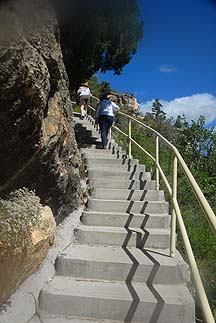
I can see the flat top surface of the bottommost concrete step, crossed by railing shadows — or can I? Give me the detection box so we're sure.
[42,276,192,304]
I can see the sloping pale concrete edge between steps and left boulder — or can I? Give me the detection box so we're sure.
[0,207,83,323]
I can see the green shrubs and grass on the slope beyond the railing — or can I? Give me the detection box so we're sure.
[115,100,216,322]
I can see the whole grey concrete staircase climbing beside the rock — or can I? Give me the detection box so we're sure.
[36,118,195,323]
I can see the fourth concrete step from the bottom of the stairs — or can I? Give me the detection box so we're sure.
[82,211,170,229]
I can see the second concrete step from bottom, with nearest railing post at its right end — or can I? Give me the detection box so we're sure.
[56,244,187,284]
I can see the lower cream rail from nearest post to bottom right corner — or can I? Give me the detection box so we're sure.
[173,199,215,323]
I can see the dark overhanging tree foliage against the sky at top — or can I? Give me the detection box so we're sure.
[53,0,143,88]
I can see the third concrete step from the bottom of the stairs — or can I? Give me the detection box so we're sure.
[75,225,170,249]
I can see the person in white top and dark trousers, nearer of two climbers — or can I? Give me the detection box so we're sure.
[95,93,119,149]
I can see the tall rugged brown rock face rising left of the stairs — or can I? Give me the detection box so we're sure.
[0,0,80,222]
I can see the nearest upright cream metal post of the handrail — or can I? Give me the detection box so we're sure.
[170,155,178,258]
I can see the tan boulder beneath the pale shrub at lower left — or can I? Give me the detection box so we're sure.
[0,206,56,304]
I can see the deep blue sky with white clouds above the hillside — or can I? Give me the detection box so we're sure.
[99,0,216,124]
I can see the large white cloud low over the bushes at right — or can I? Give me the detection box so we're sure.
[140,93,216,124]
